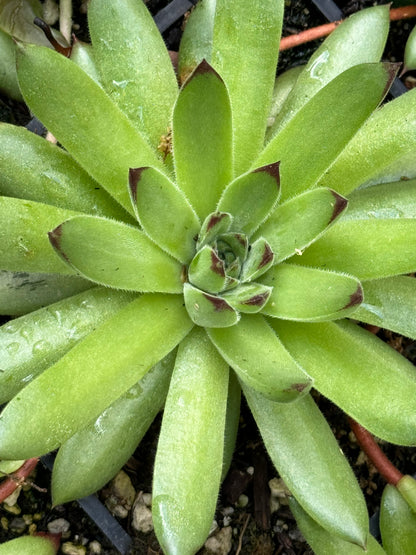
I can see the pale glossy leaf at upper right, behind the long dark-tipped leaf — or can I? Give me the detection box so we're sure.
[272,6,389,133]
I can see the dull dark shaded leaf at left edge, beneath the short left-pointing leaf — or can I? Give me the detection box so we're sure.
[0,270,93,316]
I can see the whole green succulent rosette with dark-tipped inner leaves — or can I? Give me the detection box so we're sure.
[0,0,416,555]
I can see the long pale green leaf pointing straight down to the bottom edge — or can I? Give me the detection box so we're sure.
[152,329,228,555]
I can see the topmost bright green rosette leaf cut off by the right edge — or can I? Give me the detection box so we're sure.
[320,86,416,194]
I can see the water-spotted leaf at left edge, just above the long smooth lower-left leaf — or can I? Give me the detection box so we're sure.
[0,288,134,403]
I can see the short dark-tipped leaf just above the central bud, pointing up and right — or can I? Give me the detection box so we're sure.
[217,162,280,236]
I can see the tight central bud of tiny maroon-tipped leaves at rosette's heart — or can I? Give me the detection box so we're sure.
[184,212,274,328]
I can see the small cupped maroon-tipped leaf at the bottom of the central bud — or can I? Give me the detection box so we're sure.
[183,283,240,328]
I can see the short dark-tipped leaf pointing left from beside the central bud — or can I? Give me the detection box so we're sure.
[49,216,182,293]
